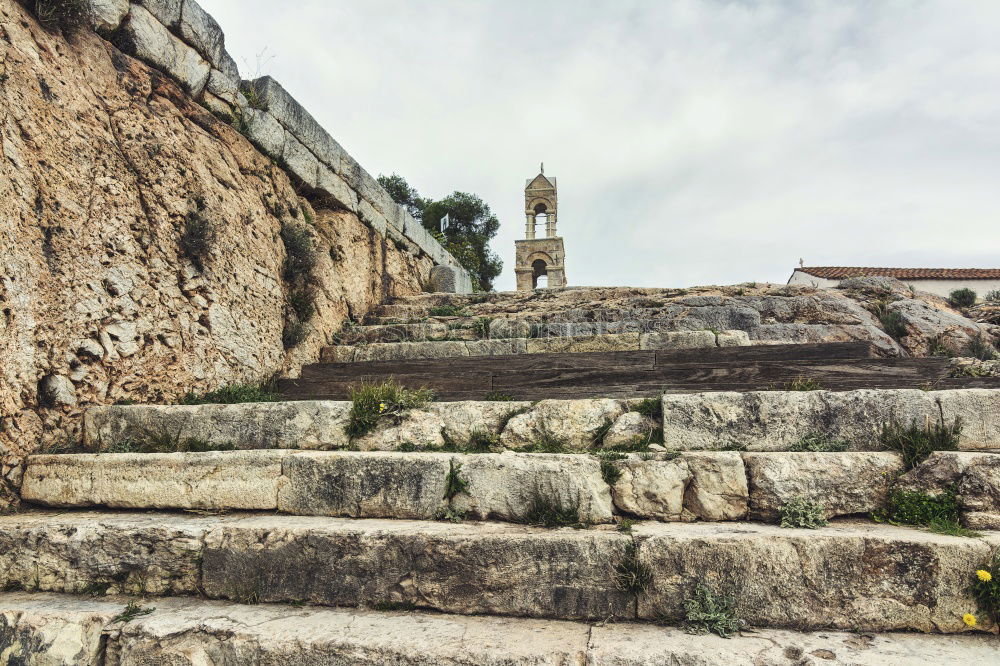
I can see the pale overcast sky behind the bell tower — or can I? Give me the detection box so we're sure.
[200,0,1000,289]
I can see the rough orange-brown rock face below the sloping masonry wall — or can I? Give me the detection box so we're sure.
[0,0,432,498]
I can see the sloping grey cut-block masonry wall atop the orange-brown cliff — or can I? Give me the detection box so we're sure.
[90,0,472,293]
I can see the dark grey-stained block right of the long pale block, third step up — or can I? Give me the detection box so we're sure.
[278,452,452,520]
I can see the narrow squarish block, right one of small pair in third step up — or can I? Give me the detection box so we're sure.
[682,451,750,520]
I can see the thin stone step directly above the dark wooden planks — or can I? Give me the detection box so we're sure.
[320,324,750,363]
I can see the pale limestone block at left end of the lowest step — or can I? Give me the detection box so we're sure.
[0,592,114,666]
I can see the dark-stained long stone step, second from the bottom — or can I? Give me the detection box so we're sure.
[0,511,1000,633]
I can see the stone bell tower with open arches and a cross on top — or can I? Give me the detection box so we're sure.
[514,164,566,291]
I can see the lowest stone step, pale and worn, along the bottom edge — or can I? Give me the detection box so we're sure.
[0,593,997,666]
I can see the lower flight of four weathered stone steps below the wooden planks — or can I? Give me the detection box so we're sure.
[0,382,1000,665]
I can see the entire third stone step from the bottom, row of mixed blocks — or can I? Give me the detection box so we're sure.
[21,450,1000,529]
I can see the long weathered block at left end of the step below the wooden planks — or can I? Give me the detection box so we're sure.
[83,400,351,450]
